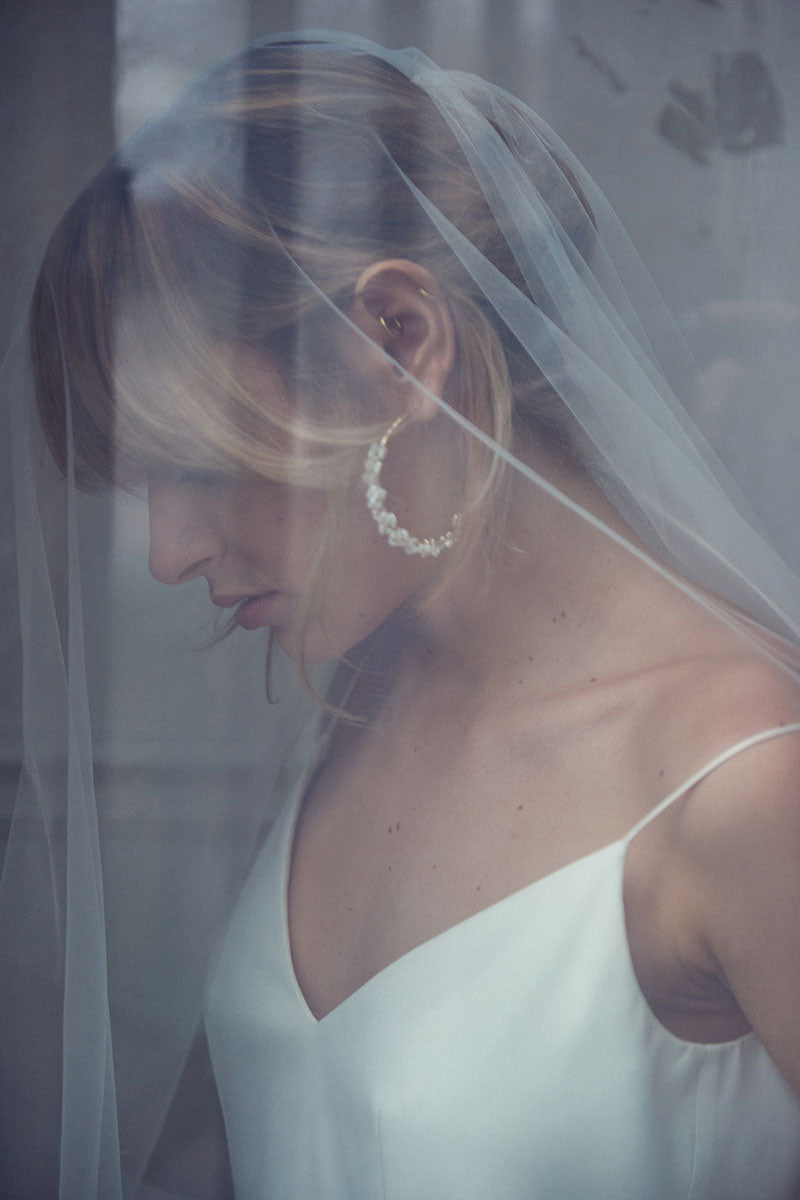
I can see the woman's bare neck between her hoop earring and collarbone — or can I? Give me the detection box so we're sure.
[414,455,666,691]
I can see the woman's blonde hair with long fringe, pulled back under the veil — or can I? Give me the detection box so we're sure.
[30,43,587,696]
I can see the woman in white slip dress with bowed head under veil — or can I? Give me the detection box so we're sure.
[4,35,800,1200]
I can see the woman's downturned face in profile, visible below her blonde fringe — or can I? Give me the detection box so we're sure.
[148,350,453,662]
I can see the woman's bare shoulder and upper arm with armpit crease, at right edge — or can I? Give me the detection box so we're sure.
[627,649,800,1070]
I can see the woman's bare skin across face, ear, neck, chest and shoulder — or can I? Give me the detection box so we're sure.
[150,260,800,1094]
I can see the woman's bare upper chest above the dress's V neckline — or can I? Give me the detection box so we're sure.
[288,715,655,1014]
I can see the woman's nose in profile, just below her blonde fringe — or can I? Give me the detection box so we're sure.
[148,481,224,583]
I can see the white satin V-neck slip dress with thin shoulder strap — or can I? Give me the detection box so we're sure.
[206,726,800,1200]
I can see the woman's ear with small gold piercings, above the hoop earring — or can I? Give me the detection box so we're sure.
[349,258,456,420]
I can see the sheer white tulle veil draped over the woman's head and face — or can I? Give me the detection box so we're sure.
[0,34,800,1200]
